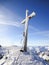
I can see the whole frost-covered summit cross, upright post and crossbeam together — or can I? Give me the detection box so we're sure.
[21,10,36,52]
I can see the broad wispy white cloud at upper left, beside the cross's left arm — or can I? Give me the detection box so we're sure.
[0,5,22,27]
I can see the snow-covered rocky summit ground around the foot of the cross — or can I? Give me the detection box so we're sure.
[0,46,49,65]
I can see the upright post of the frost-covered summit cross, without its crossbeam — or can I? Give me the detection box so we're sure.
[24,10,29,52]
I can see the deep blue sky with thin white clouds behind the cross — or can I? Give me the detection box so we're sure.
[0,0,49,46]
